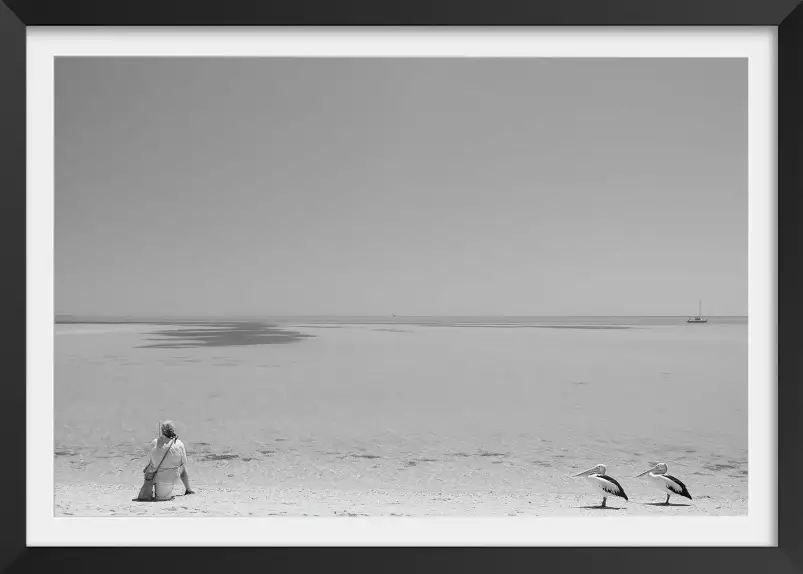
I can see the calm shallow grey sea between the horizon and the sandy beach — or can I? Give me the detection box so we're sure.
[54,317,748,504]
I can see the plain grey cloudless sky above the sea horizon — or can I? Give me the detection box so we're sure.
[55,58,748,317]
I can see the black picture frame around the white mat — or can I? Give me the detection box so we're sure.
[0,0,803,574]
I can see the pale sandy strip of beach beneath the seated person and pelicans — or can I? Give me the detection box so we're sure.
[54,482,747,518]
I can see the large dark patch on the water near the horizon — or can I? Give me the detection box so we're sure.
[140,323,315,352]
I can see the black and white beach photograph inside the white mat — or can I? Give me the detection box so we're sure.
[52,57,752,518]
